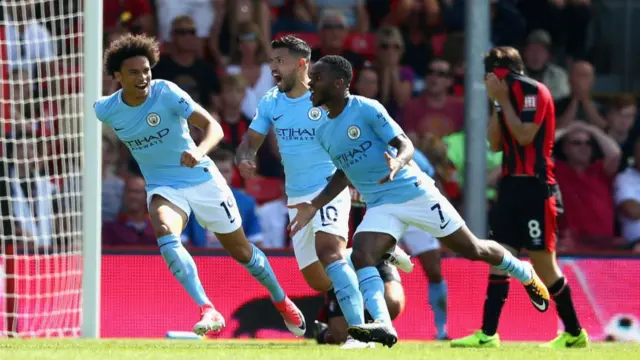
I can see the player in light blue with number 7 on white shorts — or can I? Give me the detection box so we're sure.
[289,56,549,347]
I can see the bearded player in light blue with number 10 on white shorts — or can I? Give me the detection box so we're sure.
[236,36,413,348]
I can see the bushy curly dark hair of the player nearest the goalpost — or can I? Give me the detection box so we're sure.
[104,35,160,76]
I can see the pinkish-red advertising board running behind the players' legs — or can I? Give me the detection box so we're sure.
[0,255,640,341]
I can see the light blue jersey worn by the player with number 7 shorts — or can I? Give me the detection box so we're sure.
[316,95,433,207]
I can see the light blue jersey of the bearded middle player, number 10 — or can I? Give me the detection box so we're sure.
[249,87,336,197]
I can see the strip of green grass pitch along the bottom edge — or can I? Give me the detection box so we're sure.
[0,339,640,360]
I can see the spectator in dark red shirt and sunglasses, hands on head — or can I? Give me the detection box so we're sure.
[556,121,621,250]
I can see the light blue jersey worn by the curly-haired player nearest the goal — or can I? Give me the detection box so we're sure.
[94,80,214,191]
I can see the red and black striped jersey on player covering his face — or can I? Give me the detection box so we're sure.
[498,73,556,184]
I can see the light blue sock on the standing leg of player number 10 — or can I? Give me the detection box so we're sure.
[325,259,364,326]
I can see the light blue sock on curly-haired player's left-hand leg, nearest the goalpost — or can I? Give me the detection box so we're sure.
[158,235,211,306]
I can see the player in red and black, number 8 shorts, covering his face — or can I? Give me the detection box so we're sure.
[451,47,589,348]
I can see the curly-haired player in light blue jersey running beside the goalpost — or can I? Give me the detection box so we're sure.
[94,35,306,336]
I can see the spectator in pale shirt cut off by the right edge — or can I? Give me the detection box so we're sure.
[615,139,640,252]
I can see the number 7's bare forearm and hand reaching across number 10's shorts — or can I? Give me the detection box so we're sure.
[287,170,349,236]
